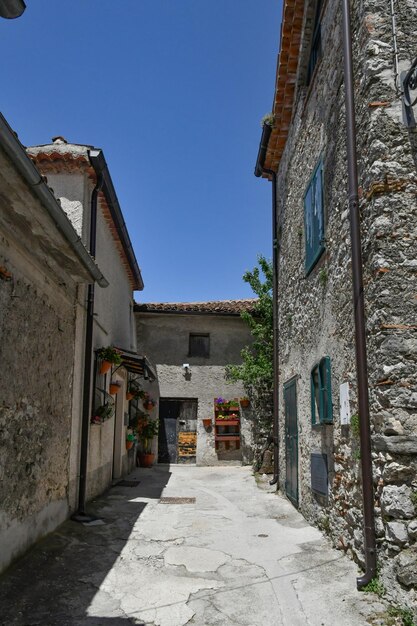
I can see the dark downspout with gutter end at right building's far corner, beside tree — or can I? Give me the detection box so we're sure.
[255,124,279,485]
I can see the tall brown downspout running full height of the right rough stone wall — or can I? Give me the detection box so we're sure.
[342,0,376,589]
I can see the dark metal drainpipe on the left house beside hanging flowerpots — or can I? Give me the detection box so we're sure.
[71,174,103,522]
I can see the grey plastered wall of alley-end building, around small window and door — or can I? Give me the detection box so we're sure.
[136,312,253,465]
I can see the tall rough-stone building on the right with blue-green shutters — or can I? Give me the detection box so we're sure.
[258,0,417,608]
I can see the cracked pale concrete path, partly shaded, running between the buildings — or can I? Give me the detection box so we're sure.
[0,466,381,626]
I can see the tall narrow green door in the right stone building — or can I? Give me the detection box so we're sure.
[284,378,298,506]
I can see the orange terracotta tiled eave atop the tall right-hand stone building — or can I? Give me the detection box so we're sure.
[263,0,305,178]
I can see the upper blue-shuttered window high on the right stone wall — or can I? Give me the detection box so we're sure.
[304,161,324,274]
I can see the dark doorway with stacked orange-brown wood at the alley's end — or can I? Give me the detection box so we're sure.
[158,398,198,463]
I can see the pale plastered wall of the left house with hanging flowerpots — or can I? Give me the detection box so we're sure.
[31,157,136,507]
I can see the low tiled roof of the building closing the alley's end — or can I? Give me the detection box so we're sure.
[135,298,258,315]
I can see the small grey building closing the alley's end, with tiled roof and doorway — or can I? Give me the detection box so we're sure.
[135,300,254,465]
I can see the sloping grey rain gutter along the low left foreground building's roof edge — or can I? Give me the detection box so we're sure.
[0,113,109,287]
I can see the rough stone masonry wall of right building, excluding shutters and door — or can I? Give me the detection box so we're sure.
[277,0,417,604]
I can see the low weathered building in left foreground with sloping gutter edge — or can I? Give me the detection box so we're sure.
[0,115,107,571]
